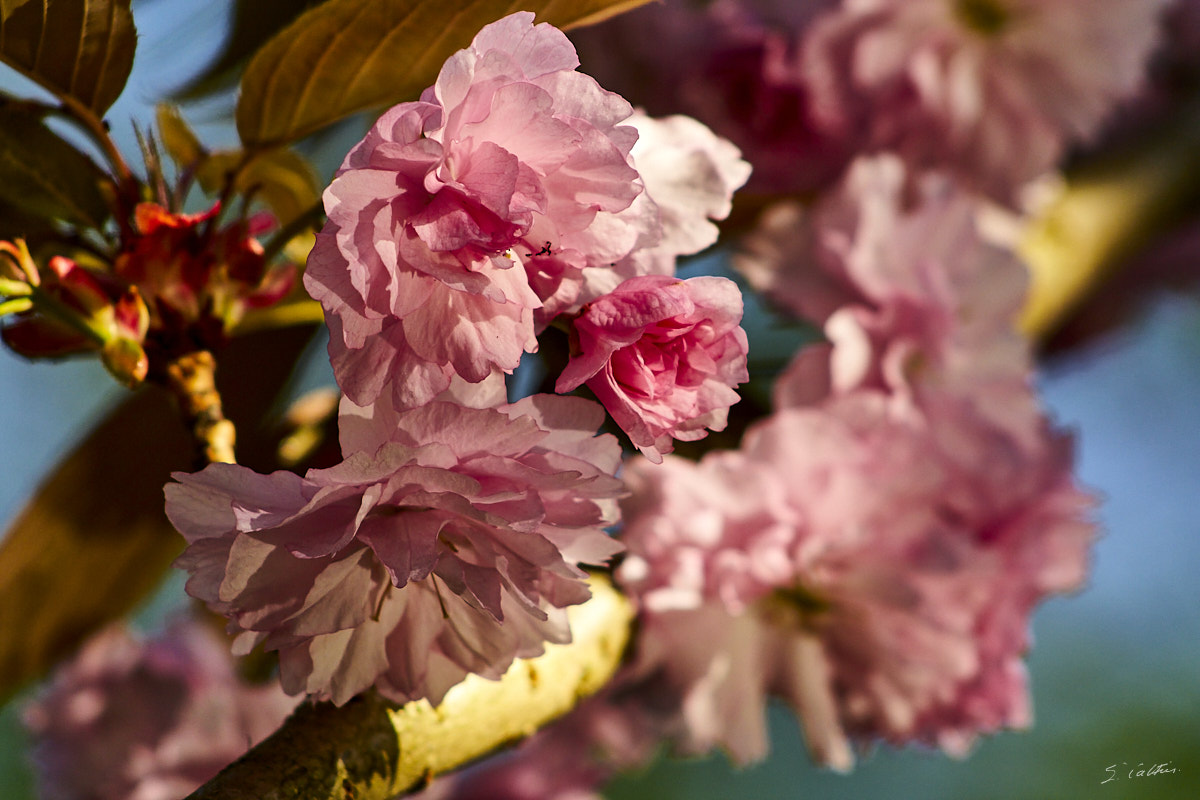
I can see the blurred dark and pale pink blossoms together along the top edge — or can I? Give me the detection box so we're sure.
[577,0,1170,204]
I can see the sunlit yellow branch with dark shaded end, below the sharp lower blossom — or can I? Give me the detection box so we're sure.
[188,577,632,800]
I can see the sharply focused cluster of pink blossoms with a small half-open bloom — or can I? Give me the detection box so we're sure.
[167,13,749,704]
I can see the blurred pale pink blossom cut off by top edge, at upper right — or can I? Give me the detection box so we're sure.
[803,0,1165,204]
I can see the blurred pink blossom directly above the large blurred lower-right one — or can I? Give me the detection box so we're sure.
[736,156,1039,439]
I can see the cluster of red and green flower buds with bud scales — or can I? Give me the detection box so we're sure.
[0,203,294,386]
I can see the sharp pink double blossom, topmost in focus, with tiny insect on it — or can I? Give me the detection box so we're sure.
[305,12,654,407]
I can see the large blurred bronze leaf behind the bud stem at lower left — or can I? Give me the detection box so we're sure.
[0,326,312,703]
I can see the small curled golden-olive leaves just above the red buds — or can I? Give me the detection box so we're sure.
[196,150,320,227]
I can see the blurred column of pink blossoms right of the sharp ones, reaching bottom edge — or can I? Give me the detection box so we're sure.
[422,157,1094,800]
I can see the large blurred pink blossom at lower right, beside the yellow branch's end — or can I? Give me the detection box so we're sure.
[618,391,1094,769]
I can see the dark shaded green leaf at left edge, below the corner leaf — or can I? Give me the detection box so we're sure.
[0,109,109,228]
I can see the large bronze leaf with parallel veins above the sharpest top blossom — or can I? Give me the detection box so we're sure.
[238,0,648,148]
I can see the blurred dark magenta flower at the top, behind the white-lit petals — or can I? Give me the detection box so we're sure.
[571,0,853,193]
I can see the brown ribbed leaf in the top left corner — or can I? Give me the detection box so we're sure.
[0,0,137,115]
